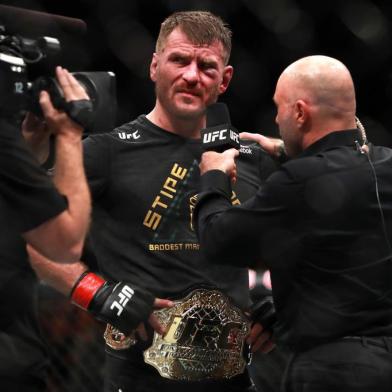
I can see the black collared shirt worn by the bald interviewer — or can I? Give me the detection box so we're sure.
[194,130,392,350]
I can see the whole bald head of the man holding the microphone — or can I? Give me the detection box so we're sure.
[274,56,356,156]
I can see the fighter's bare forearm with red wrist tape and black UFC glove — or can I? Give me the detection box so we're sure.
[27,245,162,334]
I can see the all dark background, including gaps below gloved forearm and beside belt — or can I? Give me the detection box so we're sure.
[0,0,392,392]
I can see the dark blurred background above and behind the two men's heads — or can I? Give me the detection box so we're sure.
[0,0,392,145]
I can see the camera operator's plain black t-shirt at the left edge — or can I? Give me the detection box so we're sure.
[0,120,67,379]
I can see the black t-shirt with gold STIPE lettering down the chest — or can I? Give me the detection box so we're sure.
[84,116,275,308]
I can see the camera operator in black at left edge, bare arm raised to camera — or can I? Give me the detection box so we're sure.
[0,67,90,391]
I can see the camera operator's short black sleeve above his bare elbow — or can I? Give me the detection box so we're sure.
[0,120,67,232]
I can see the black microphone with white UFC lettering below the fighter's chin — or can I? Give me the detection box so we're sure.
[200,102,240,152]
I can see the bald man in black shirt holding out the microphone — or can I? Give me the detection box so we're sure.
[195,56,392,392]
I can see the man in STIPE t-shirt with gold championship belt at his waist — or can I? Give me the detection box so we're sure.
[29,11,274,392]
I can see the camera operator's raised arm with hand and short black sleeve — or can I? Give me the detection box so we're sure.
[0,67,90,262]
